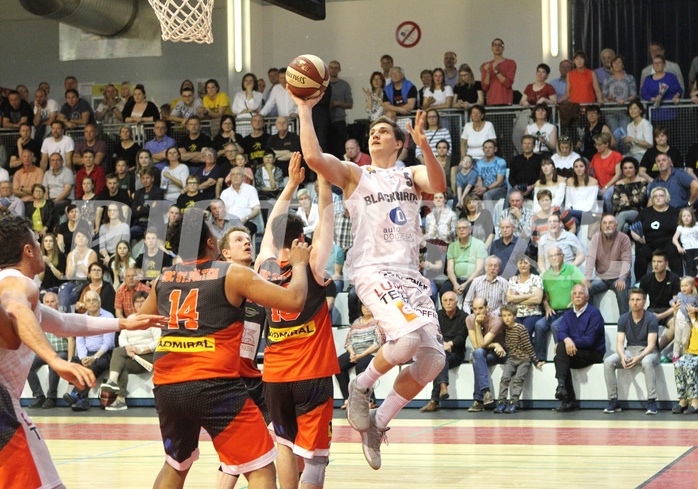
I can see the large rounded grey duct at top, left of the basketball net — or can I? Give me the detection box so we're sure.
[19,0,138,37]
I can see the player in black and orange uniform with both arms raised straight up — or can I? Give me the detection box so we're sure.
[255,153,339,489]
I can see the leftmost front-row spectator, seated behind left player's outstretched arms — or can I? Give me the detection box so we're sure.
[27,292,75,409]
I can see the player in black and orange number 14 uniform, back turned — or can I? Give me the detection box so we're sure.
[141,209,312,489]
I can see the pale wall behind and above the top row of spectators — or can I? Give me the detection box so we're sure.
[0,0,566,119]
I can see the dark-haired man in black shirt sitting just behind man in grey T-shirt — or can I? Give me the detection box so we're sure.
[640,249,680,356]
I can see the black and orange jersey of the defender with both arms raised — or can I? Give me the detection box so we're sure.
[259,258,339,382]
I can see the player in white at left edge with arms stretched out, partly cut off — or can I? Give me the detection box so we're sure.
[0,217,167,489]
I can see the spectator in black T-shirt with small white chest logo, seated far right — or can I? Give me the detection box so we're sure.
[630,187,683,278]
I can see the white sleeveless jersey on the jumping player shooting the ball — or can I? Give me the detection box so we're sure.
[345,166,422,270]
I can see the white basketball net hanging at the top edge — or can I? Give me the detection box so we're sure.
[148,0,214,44]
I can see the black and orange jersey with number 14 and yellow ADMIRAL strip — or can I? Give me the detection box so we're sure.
[153,260,245,385]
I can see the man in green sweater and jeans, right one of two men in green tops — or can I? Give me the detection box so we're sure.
[533,246,584,361]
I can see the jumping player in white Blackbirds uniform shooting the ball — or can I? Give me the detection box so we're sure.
[293,91,446,469]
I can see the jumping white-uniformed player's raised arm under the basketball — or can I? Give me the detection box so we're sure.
[287,89,360,189]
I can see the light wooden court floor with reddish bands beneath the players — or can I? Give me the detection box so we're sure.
[28,408,698,489]
